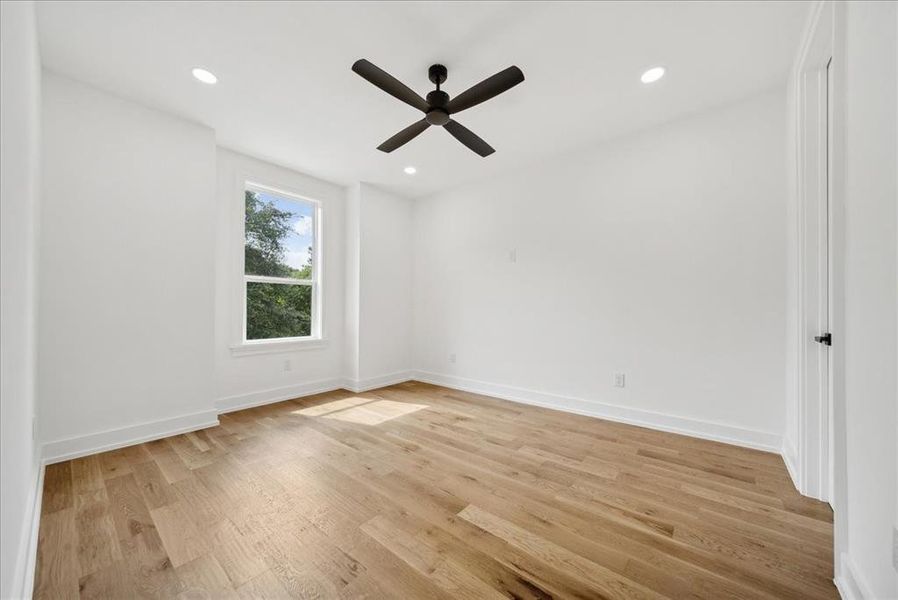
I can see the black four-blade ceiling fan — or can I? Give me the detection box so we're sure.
[352,58,524,156]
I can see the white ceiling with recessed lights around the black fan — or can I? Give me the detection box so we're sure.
[38,1,808,197]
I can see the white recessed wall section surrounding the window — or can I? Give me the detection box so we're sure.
[209,150,346,410]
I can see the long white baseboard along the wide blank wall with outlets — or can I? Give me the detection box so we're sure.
[414,371,782,454]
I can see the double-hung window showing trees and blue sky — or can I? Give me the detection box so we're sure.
[243,184,321,342]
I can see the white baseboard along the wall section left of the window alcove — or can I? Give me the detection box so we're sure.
[41,410,218,465]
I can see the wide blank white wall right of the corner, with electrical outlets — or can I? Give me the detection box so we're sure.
[413,90,787,451]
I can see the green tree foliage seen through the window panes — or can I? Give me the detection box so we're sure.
[244,191,312,340]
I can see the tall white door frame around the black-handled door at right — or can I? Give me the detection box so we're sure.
[787,2,845,505]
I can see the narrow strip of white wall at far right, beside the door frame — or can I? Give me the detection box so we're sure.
[836,2,898,599]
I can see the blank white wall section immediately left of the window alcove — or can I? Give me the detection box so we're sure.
[38,73,216,457]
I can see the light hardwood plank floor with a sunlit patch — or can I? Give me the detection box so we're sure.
[35,383,838,600]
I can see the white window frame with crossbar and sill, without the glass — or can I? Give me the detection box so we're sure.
[231,177,327,356]
